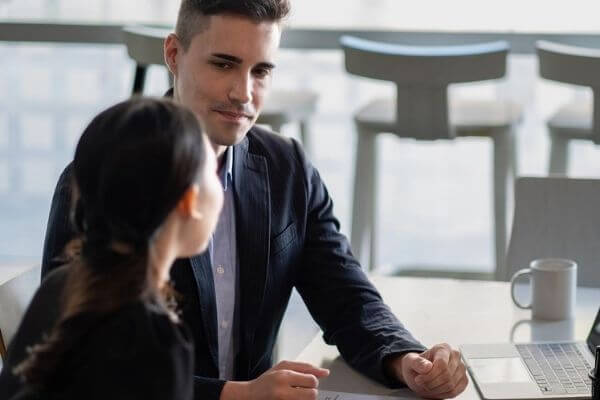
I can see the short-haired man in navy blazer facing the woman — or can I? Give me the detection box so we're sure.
[8,0,468,400]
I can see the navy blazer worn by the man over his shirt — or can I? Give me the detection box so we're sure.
[34,126,425,399]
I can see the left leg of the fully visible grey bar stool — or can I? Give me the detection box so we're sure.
[350,130,377,270]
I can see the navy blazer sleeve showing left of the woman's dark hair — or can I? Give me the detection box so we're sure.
[42,164,75,279]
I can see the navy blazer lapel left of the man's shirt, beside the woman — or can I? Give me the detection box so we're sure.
[190,250,219,371]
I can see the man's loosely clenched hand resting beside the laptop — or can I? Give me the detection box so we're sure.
[387,343,469,399]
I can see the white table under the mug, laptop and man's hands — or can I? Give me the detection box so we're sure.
[298,277,600,399]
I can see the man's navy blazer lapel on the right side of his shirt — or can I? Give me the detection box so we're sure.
[233,137,271,368]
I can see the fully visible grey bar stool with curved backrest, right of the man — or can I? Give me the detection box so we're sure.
[341,36,521,269]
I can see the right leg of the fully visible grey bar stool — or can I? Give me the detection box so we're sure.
[493,129,515,279]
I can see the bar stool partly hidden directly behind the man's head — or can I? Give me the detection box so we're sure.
[123,26,318,154]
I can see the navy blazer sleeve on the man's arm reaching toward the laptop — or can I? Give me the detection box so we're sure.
[294,142,426,386]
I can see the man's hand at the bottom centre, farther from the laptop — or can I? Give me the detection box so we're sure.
[221,361,329,400]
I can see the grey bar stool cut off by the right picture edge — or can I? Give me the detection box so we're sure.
[536,41,600,175]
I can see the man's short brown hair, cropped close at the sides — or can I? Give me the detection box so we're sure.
[175,0,290,50]
